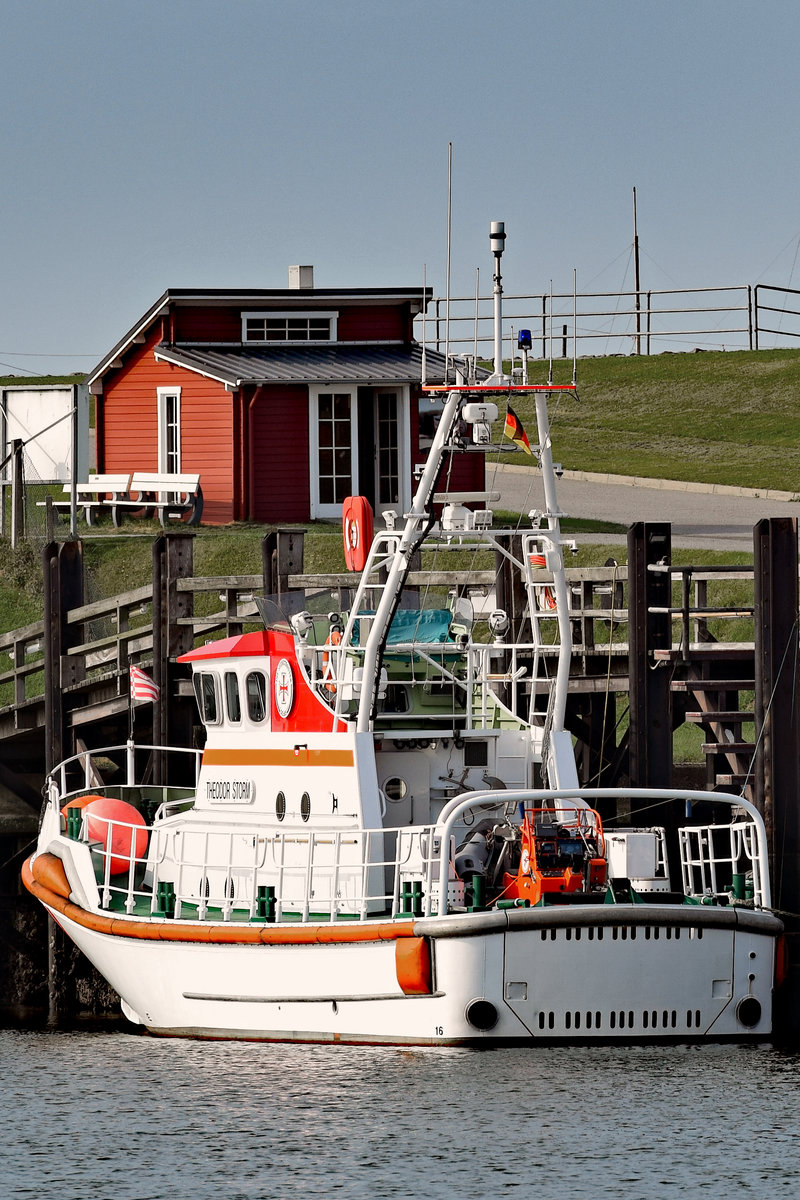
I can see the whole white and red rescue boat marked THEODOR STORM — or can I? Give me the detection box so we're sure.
[23,222,782,1044]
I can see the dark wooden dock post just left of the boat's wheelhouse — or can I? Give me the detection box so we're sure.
[152,533,194,784]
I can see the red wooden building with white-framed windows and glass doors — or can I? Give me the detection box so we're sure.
[89,276,483,524]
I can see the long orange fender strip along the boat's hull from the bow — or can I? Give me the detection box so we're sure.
[22,854,414,946]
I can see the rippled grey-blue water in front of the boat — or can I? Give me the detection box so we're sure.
[0,1031,800,1200]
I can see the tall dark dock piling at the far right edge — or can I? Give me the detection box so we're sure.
[753,517,800,1040]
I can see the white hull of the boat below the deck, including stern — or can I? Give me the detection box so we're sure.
[45,905,780,1044]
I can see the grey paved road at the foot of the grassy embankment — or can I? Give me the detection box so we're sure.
[487,464,800,551]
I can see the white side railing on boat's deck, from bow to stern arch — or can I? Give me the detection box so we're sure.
[62,810,450,922]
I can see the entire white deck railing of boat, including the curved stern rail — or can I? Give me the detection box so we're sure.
[56,788,770,922]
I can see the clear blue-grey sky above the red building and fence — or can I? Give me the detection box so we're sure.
[0,0,800,373]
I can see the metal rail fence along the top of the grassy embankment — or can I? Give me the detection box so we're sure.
[415,283,800,359]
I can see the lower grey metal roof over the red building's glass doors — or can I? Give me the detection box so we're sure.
[149,342,445,388]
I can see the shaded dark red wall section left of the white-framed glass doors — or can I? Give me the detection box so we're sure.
[251,386,311,524]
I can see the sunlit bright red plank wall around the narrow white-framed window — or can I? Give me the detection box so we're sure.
[97,331,237,524]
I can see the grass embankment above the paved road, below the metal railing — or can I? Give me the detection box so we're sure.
[509,350,800,492]
